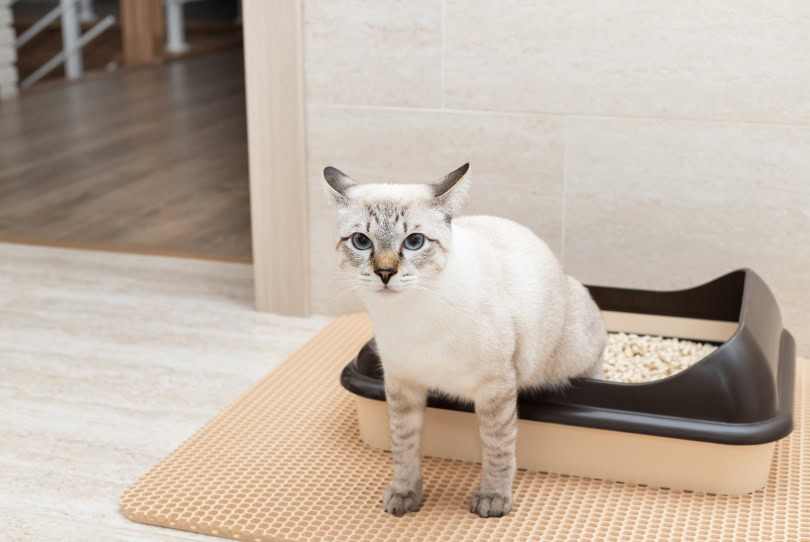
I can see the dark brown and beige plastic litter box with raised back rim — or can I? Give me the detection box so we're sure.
[340,269,796,495]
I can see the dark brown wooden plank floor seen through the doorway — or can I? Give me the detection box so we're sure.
[0,50,250,261]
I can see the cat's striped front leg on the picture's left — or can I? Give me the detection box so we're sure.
[383,376,427,516]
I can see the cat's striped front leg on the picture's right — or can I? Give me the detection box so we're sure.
[470,381,517,518]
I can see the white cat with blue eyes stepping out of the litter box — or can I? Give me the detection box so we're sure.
[324,164,607,517]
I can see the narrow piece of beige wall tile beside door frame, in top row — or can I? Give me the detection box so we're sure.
[304,0,442,107]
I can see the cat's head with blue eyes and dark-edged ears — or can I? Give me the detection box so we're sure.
[323,164,469,297]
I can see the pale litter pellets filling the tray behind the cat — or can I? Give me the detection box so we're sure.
[602,333,717,383]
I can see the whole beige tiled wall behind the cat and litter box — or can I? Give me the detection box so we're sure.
[304,0,810,355]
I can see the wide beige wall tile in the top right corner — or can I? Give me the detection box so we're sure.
[445,0,810,122]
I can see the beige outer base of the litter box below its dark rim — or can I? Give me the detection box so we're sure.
[356,397,776,495]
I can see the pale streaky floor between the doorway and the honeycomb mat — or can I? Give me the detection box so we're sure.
[0,243,329,541]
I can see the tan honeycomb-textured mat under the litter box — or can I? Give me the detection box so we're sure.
[121,315,810,542]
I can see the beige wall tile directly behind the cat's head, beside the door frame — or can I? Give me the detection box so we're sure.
[308,106,563,313]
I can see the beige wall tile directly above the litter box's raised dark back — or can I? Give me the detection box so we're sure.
[564,119,810,354]
